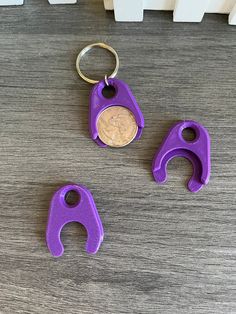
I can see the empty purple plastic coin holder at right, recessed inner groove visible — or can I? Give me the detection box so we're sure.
[152,120,211,192]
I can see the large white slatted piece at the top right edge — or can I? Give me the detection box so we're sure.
[104,0,236,25]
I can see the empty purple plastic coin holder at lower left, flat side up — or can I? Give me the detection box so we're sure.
[46,184,104,257]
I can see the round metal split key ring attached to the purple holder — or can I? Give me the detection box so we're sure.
[76,43,120,84]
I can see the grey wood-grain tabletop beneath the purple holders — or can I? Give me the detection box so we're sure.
[0,0,236,314]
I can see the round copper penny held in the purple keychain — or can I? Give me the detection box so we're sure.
[97,106,138,147]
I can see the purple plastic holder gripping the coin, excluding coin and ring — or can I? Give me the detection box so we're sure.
[89,78,144,147]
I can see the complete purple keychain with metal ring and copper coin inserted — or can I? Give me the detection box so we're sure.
[76,43,144,147]
